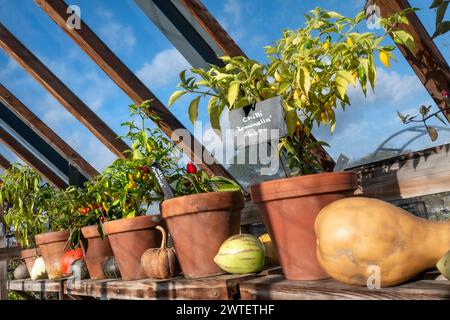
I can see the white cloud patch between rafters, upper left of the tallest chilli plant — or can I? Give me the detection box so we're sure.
[136,48,190,88]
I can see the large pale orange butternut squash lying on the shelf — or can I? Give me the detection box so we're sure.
[315,197,450,287]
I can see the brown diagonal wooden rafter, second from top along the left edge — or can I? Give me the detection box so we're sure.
[0,83,98,177]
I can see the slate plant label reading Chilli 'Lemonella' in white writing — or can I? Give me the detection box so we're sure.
[228,96,287,149]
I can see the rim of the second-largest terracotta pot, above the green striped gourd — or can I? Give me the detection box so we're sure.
[161,191,244,219]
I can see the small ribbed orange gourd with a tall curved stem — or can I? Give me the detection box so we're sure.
[141,226,180,279]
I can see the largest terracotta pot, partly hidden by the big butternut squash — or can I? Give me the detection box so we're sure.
[250,172,356,280]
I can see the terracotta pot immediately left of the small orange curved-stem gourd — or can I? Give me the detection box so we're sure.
[104,215,161,280]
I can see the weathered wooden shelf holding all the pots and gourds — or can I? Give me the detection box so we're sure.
[8,267,450,300]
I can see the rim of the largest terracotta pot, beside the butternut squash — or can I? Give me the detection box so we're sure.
[249,171,357,203]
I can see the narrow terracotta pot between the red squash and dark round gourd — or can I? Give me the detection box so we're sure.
[81,225,114,280]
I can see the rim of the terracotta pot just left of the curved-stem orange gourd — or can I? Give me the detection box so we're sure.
[103,215,159,235]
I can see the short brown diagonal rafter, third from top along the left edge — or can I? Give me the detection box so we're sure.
[0,127,67,188]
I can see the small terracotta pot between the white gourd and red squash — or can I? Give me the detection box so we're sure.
[35,230,70,279]
